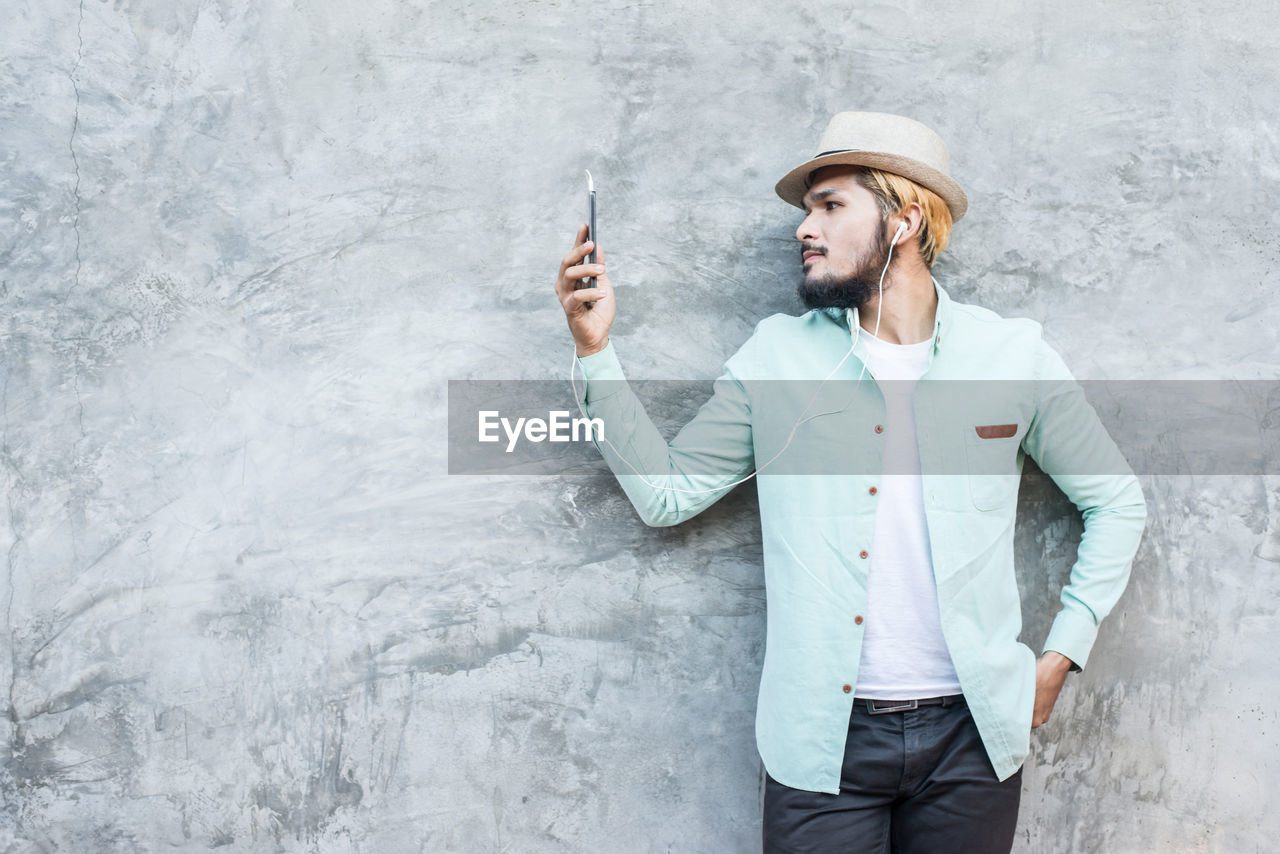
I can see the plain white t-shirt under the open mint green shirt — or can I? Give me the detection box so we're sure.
[854,330,960,700]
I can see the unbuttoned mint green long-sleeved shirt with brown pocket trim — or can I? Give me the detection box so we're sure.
[579,282,1147,794]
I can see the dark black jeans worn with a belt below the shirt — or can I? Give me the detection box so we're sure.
[763,702,1023,854]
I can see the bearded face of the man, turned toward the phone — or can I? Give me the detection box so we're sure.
[796,166,888,309]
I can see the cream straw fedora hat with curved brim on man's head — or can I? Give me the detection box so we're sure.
[774,113,969,222]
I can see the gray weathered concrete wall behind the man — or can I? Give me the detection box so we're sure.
[0,0,1280,853]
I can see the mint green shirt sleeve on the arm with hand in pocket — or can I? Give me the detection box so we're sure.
[1023,341,1147,671]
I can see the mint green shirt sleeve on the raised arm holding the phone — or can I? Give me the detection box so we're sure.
[577,341,755,528]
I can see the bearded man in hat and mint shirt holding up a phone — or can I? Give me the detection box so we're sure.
[556,113,1146,854]
